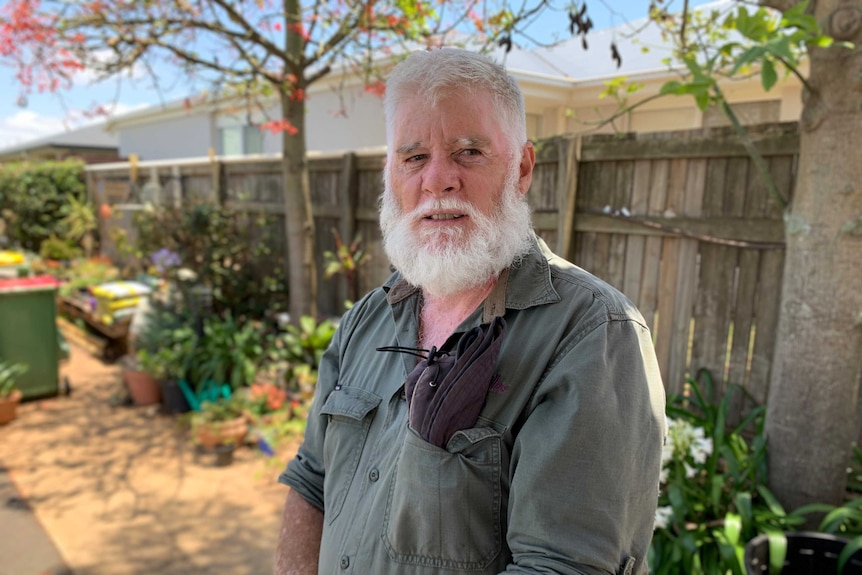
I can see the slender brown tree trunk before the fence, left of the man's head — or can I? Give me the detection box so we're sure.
[281,85,317,324]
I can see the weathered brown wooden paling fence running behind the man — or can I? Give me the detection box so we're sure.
[88,124,799,418]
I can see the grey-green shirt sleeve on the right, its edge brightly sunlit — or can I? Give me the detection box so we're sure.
[505,320,666,575]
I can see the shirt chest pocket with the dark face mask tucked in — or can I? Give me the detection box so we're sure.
[383,428,503,572]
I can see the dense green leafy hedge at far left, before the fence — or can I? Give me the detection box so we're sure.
[0,160,86,252]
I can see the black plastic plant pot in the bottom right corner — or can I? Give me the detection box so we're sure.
[745,531,862,575]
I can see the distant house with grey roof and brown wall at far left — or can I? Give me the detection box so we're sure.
[0,123,121,164]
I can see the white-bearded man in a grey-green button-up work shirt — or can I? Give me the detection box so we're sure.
[275,49,665,575]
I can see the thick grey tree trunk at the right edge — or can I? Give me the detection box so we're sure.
[766,0,862,510]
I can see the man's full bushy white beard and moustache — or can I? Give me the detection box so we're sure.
[380,166,533,297]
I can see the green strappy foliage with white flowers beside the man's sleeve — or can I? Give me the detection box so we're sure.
[649,370,803,575]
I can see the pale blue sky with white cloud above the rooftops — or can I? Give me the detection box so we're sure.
[0,0,706,150]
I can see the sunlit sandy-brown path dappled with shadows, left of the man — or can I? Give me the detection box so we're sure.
[0,341,300,575]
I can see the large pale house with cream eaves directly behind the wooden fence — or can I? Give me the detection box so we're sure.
[71,0,802,161]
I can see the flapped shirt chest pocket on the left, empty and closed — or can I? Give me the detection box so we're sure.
[320,387,381,523]
